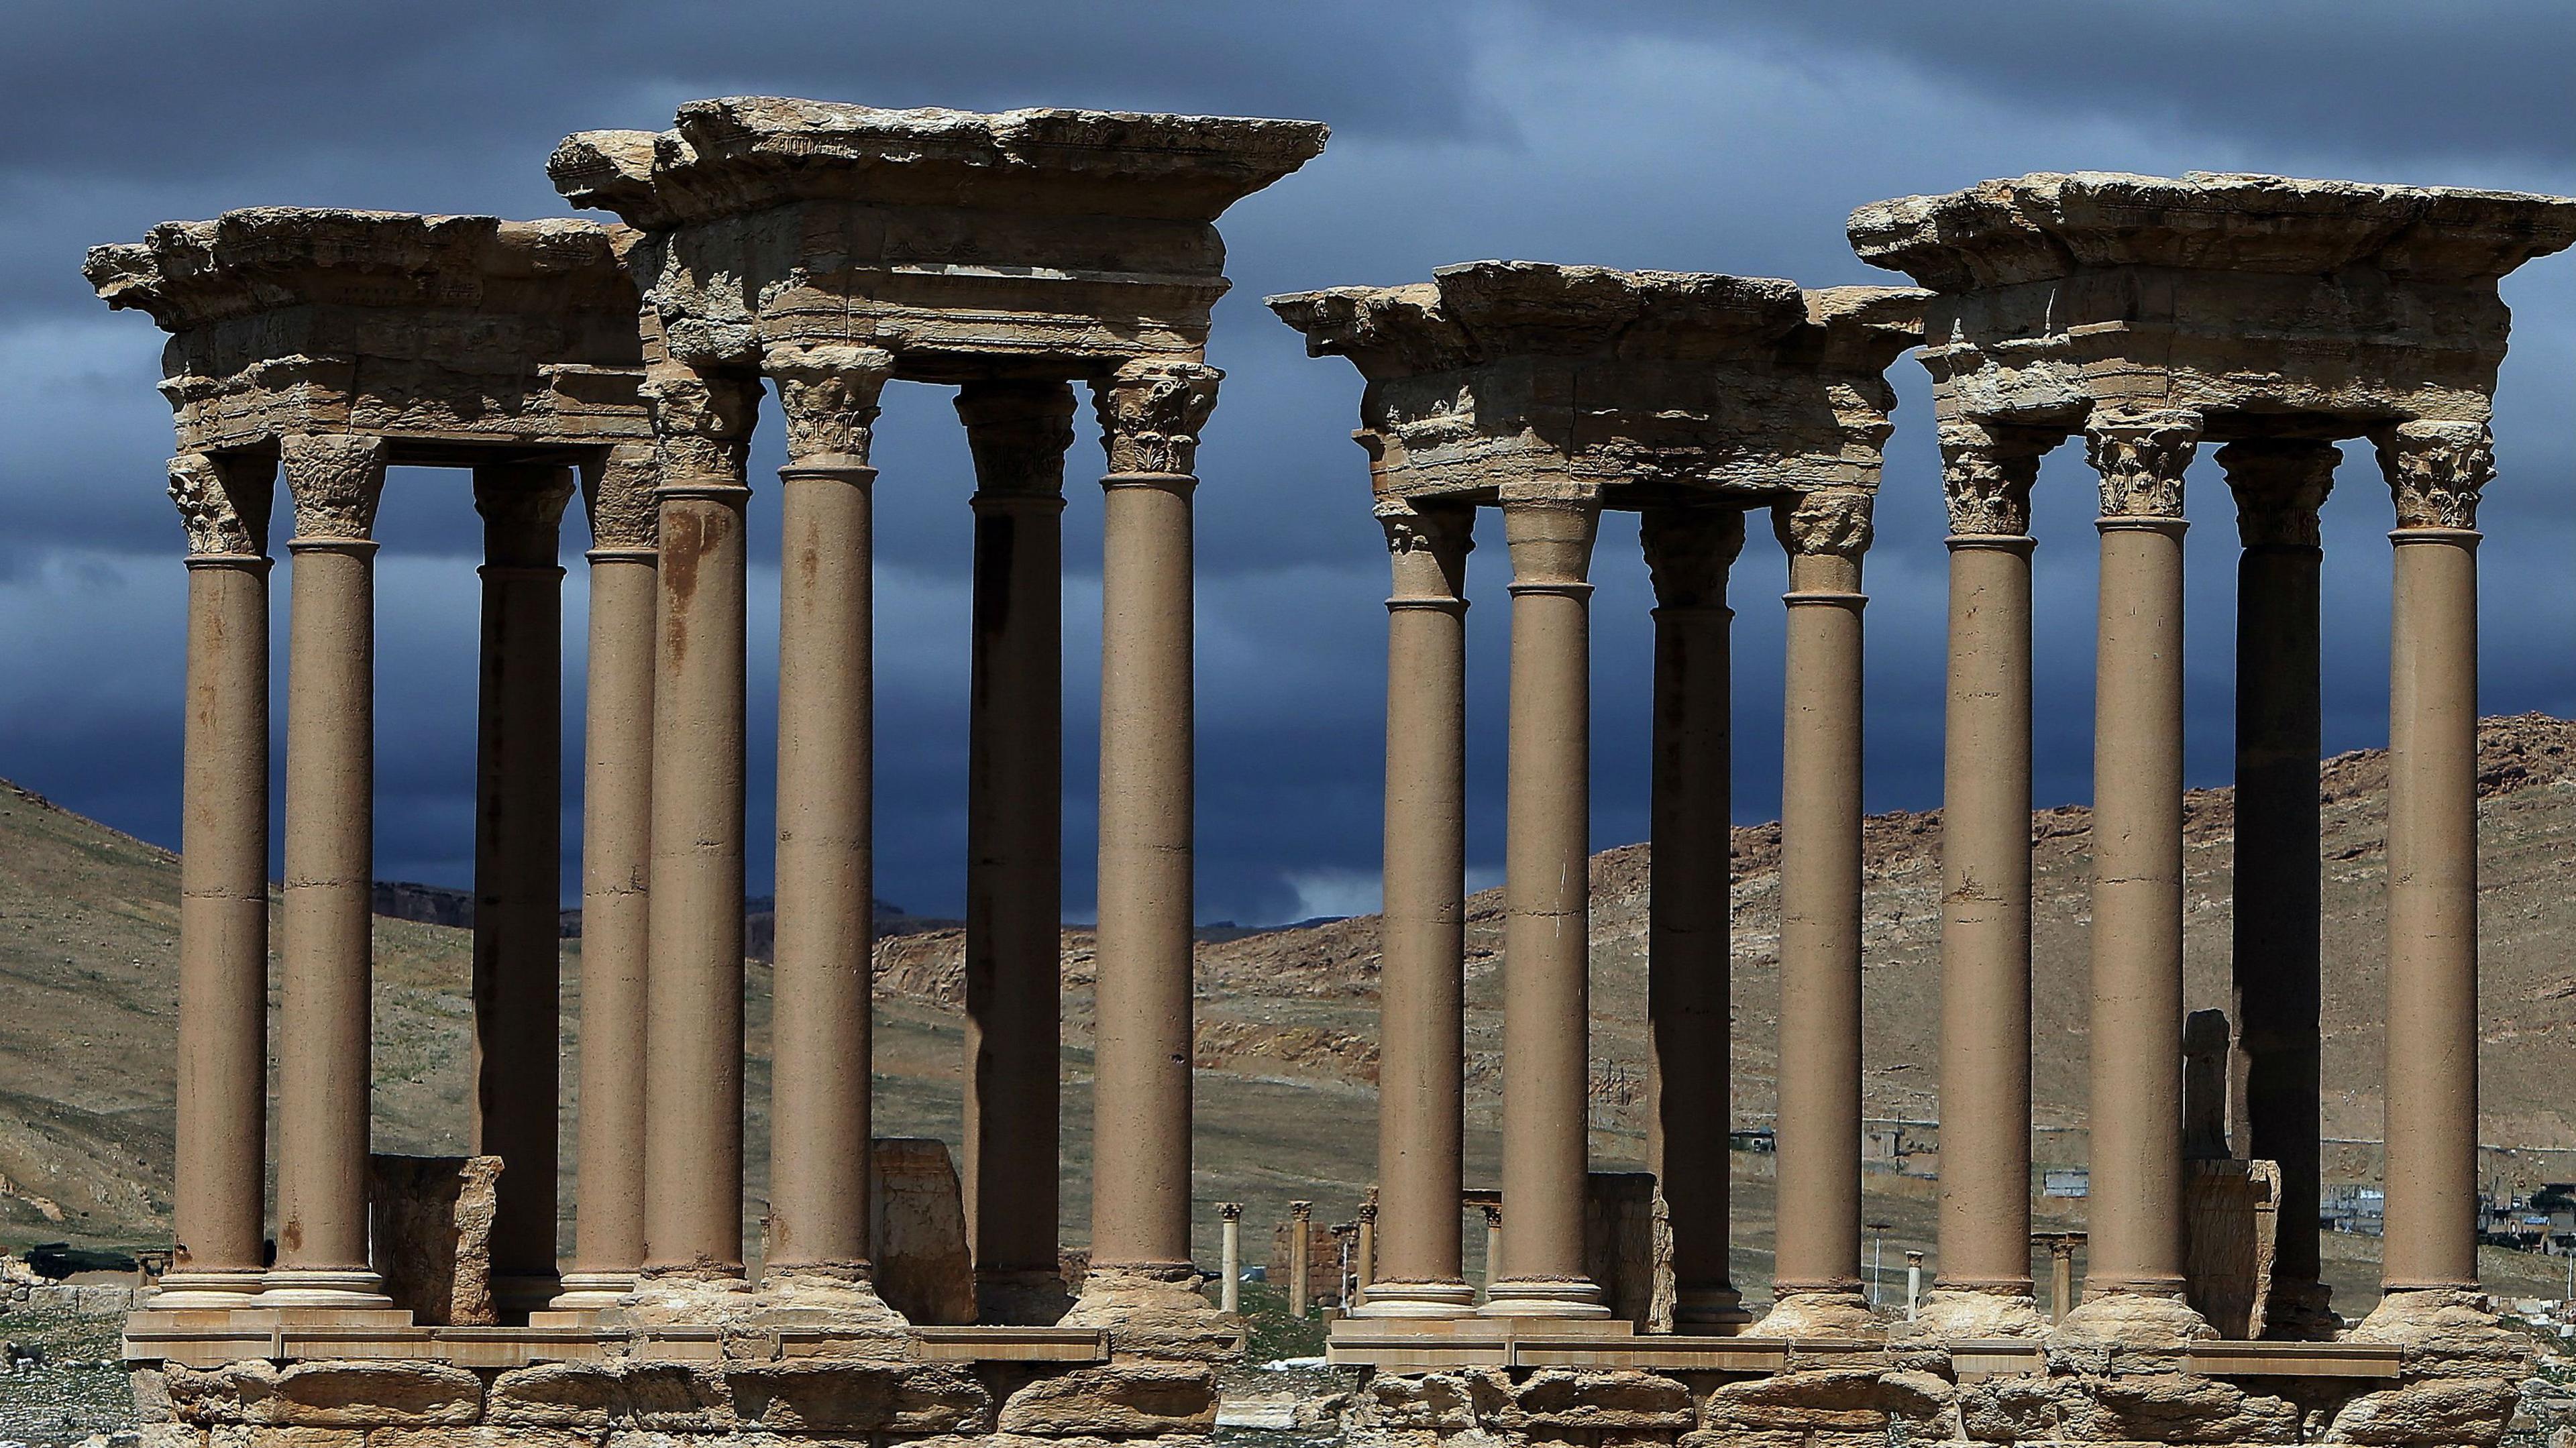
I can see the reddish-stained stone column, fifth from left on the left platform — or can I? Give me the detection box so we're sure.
[639,364,760,1283]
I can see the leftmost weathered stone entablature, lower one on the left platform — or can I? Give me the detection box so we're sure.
[85,206,652,463]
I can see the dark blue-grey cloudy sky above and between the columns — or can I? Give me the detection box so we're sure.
[0,0,2576,922]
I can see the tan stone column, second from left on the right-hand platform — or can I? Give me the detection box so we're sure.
[1479,497,1610,1317]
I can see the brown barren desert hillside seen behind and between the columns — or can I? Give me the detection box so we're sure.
[15,716,2576,1306]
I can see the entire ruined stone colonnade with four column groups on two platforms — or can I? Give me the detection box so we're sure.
[70,98,2576,1448]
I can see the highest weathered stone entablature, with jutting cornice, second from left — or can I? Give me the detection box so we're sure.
[549,95,1327,382]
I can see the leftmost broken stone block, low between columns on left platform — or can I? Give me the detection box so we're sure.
[368,1154,500,1327]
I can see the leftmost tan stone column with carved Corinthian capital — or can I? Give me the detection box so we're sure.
[150,453,276,1311]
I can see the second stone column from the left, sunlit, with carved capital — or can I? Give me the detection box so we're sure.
[263,433,392,1309]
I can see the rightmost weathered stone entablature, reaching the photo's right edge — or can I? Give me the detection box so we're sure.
[1849,170,2576,441]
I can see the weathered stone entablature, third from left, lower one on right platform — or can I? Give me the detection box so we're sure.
[1270,260,1929,508]
